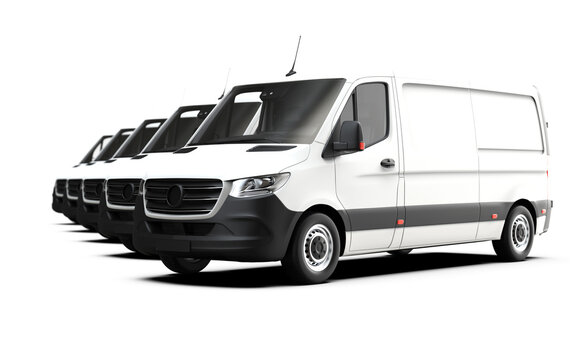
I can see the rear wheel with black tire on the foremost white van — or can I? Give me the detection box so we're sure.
[493,206,534,261]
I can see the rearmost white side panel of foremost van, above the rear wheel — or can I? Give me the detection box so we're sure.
[471,88,548,236]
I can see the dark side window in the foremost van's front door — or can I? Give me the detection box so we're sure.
[334,83,388,147]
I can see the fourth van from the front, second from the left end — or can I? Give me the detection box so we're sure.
[61,128,135,222]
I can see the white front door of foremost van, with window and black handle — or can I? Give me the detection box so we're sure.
[333,78,403,253]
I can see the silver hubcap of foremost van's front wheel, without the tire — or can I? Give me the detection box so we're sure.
[304,224,333,271]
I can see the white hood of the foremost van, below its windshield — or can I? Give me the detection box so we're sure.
[141,143,310,181]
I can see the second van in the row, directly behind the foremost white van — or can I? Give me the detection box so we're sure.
[96,105,214,250]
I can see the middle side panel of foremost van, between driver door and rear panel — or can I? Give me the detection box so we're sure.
[392,82,479,248]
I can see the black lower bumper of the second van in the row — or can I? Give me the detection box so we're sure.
[97,193,133,239]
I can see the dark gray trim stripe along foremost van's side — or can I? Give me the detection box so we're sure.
[346,200,548,231]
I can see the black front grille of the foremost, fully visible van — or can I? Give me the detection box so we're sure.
[144,179,223,215]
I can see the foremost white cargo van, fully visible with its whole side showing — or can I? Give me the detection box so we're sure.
[133,76,552,283]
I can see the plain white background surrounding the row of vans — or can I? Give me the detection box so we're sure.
[0,0,570,359]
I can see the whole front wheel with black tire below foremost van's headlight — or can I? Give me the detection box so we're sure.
[281,213,340,284]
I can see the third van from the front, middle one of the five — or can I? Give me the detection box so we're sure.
[76,119,166,231]
